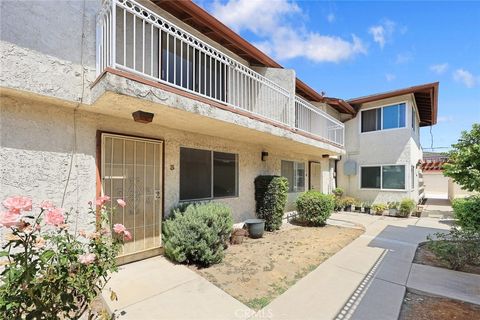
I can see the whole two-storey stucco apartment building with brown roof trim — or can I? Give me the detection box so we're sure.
[0,0,438,259]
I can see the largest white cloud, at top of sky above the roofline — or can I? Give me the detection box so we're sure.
[208,0,367,62]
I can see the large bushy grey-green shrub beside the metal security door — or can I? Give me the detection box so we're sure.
[163,202,233,267]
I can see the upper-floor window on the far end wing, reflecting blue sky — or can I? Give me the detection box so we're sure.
[361,103,406,132]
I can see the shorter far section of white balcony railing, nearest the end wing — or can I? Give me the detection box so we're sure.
[295,96,345,146]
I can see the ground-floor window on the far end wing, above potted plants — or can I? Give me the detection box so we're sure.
[360,165,405,190]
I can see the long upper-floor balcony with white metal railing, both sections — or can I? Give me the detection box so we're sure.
[96,0,344,147]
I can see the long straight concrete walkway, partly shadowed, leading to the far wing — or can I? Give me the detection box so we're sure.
[262,213,449,320]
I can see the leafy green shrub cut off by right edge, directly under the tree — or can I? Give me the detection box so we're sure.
[452,196,480,232]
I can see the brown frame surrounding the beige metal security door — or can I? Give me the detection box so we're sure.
[95,130,166,264]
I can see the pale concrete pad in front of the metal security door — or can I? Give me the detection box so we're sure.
[103,257,254,320]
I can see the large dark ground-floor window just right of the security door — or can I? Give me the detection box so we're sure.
[180,148,238,200]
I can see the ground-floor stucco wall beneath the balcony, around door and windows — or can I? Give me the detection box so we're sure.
[0,98,330,227]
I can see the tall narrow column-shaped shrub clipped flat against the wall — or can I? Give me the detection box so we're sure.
[255,176,288,231]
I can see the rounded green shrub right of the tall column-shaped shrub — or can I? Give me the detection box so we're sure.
[296,190,335,226]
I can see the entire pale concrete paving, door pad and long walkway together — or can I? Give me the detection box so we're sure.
[104,206,480,320]
